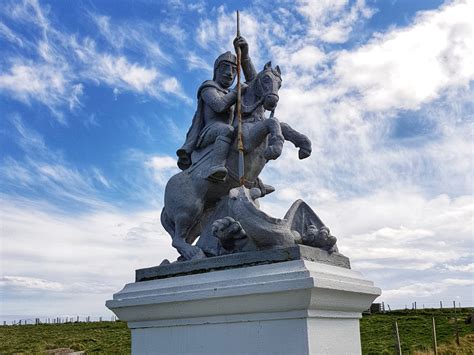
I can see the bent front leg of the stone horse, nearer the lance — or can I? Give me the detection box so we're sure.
[244,118,285,160]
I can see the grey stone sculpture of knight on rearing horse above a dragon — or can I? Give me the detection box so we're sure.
[161,36,337,261]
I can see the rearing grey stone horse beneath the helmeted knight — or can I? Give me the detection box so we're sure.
[161,62,311,260]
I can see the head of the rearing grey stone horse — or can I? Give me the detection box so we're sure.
[255,62,281,111]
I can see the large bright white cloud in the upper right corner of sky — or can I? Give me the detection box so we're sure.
[335,1,474,110]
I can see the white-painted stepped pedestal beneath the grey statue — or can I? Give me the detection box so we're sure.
[107,260,380,355]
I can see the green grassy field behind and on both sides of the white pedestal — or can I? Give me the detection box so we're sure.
[0,308,474,355]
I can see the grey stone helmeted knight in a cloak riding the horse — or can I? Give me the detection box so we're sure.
[176,37,257,181]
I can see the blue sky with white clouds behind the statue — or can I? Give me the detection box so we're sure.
[0,0,474,320]
